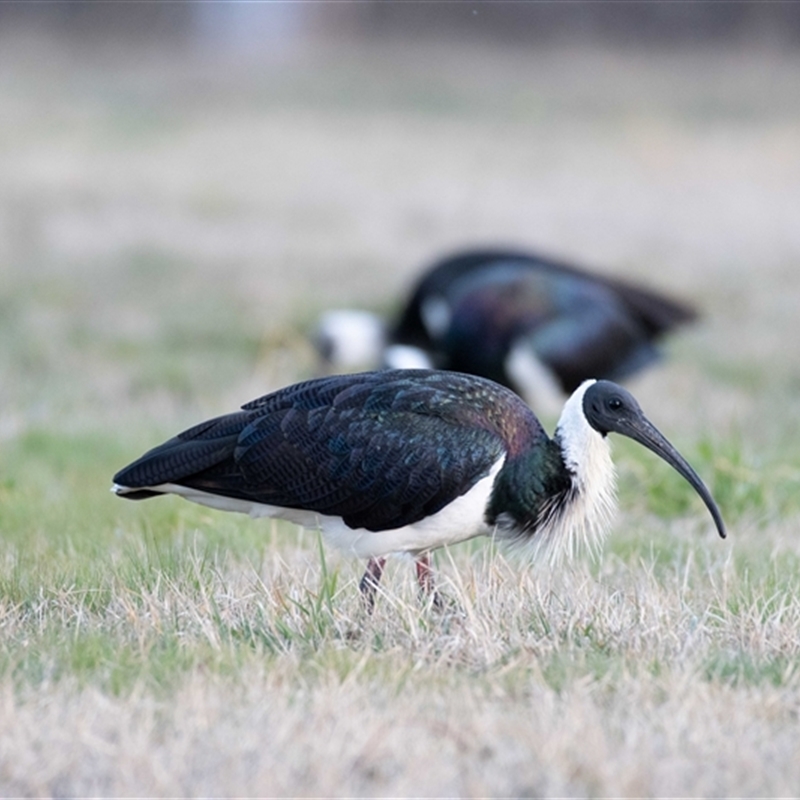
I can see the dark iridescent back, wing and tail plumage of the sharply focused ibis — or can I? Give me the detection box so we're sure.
[114,370,552,531]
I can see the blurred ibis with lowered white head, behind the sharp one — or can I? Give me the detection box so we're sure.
[315,250,695,409]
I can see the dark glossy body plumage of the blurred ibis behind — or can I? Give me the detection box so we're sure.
[390,250,695,392]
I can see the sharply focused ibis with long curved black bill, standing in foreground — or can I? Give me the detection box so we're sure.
[113,370,725,610]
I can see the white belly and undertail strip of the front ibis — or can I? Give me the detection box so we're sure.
[113,458,505,558]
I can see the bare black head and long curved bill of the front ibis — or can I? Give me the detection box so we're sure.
[583,381,725,539]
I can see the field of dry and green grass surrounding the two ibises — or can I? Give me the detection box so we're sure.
[0,29,800,797]
